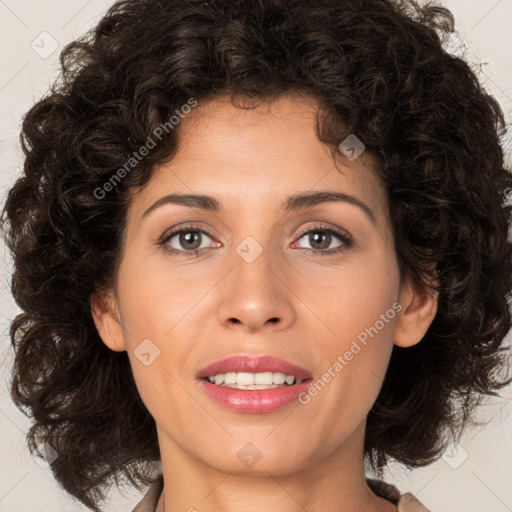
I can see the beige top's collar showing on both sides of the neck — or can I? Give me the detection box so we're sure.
[132,475,430,512]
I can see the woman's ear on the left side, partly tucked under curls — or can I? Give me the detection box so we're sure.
[90,290,126,352]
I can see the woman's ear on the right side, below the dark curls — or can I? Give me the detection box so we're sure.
[394,280,439,347]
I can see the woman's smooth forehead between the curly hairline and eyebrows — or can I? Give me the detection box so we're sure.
[127,94,387,228]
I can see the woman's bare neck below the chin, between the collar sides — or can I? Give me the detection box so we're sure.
[156,422,397,512]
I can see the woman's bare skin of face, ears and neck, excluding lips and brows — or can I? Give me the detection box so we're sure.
[92,94,437,512]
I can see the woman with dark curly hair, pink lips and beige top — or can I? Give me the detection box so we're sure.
[4,0,512,512]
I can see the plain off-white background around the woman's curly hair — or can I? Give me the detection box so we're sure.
[0,0,512,512]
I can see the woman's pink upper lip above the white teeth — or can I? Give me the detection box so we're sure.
[197,355,311,380]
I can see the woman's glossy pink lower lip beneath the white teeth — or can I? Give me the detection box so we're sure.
[200,379,312,413]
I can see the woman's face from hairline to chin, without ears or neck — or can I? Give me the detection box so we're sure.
[93,95,428,475]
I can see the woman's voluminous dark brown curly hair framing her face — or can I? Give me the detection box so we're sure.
[2,0,512,512]
